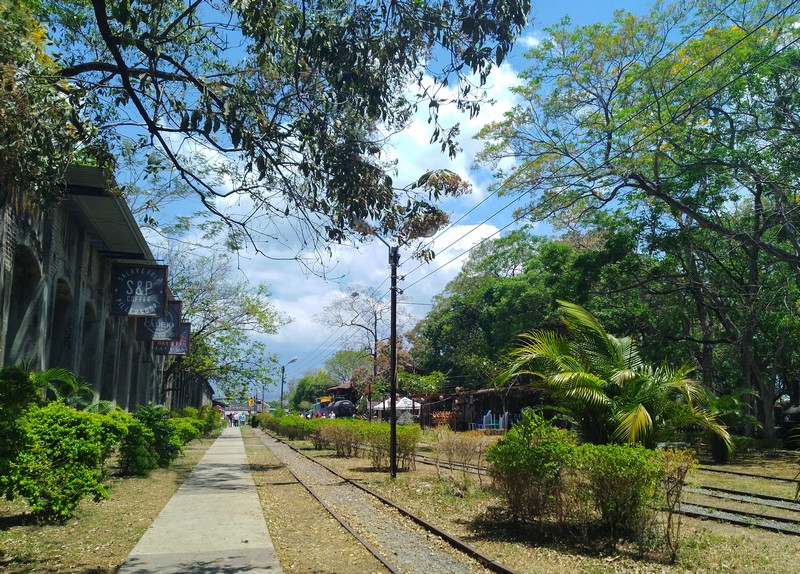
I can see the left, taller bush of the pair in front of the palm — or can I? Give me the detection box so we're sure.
[486,409,576,521]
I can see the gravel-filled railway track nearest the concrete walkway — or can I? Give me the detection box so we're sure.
[256,432,514,574]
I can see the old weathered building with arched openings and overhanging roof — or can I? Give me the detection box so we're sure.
[0,166,212,410]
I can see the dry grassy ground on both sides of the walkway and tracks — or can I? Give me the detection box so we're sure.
[0,428,800,574]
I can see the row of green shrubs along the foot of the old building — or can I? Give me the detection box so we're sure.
[0,367,220,519]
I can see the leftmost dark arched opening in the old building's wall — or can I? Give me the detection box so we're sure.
[4,246,44,365]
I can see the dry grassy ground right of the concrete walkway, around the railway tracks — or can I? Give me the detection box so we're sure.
[246,432,800,574]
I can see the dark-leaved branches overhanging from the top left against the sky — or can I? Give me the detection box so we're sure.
[28,0,530,254]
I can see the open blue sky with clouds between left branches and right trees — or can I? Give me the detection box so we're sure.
[228,0,648,399]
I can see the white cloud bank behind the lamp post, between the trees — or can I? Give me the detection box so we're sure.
[141,59,518,388]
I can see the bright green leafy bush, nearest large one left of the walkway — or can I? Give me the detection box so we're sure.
[11,401,124,519]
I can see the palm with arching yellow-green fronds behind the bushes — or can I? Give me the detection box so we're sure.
[500,301,732,448]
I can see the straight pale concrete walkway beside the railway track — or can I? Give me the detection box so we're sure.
[119,428,283,574]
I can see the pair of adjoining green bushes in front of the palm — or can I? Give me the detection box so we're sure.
[486,410,694,547]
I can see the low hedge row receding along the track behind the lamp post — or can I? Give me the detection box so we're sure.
[259,414,422,470]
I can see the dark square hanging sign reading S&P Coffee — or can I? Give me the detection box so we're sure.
[111,264,167,317]
